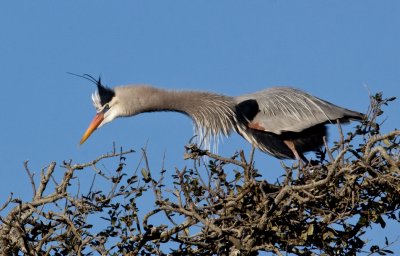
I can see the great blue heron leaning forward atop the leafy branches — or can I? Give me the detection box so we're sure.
[80,75,364,162]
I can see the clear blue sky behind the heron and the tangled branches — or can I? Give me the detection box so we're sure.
[0,0,400,253]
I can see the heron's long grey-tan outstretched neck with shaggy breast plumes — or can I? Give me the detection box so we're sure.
[116,86,236,145]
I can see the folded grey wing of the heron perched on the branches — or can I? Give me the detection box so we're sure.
[235,87,363,134]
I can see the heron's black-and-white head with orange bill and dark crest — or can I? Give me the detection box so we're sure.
[80,77,120,144]
